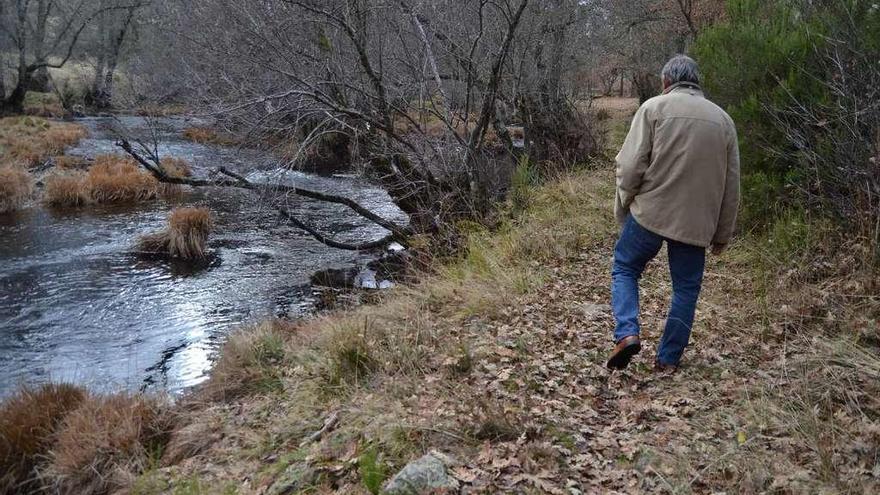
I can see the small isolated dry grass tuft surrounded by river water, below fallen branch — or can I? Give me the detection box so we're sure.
[138,208,211,260]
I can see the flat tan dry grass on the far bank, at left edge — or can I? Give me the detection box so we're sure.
[0,117,86,166]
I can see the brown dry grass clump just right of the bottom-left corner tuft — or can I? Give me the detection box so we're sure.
[41,394,174,495]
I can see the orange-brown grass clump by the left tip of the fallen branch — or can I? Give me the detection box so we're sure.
[85,155,159,203]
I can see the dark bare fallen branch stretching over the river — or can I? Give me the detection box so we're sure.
[116,138,413,251]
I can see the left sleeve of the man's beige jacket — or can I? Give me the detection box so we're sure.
[614,105,654,224]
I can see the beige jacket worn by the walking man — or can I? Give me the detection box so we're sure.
[615,83,740,252]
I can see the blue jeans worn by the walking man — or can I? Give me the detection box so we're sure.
[611,215,706,366]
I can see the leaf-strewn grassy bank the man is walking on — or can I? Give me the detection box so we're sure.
[0,99,880,494]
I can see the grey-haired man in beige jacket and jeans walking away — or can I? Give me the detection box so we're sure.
[608,55,739,370]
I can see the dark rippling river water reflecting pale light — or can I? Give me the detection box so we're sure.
[0,117,404,397]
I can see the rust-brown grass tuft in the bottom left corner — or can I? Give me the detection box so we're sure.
[0,384,86,493]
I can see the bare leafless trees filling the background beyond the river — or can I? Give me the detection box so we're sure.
[0,0,717,250]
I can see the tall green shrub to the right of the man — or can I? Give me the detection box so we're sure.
[693,0,880,244]
